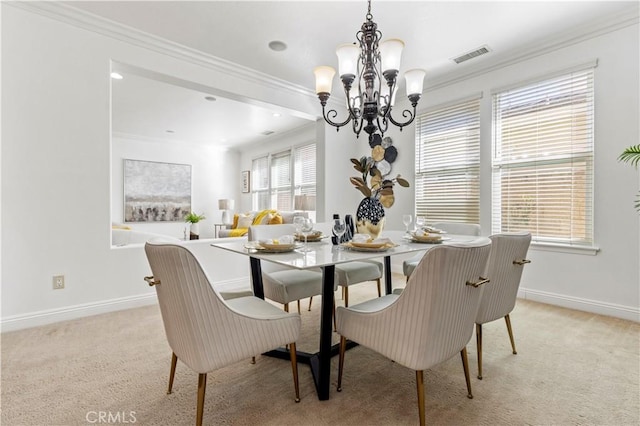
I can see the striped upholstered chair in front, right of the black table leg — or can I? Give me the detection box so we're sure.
[336,237,491,425]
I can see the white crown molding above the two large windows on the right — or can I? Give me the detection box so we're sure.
[425,4,640,92]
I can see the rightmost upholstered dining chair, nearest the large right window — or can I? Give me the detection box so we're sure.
[476,232,531,379]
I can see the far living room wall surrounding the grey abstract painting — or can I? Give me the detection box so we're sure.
[111,137,240,238]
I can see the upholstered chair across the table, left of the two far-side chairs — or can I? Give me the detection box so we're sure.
[248,224,322,313]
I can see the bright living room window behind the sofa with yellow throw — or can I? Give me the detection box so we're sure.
[252,143,316,210]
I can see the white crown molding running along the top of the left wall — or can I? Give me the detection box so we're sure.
[8,1,316,98]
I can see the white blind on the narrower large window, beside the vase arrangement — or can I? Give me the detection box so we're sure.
[415,98,480,223]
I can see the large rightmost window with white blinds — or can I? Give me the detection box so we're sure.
[492,67,594,246]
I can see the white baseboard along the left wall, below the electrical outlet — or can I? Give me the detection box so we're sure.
[0,278,247,333]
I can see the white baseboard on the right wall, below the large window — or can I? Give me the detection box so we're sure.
[518,287,640,322]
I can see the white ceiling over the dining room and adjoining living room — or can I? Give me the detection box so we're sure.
[61,0,638,150]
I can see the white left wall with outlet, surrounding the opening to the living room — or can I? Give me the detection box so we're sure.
[0,2,316,330]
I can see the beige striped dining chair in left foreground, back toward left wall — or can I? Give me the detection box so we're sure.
[145,242,300,425]
